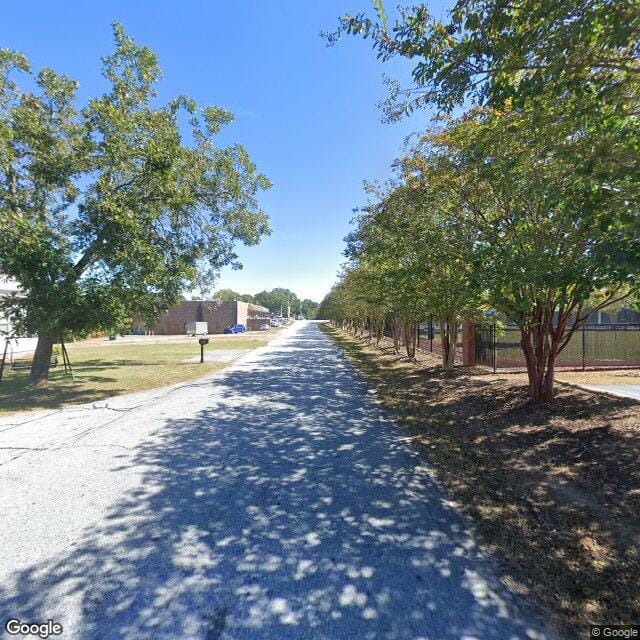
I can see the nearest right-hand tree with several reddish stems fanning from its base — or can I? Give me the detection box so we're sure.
[431,110,640,402]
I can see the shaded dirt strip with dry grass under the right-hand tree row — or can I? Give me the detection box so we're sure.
[325,327,640,638]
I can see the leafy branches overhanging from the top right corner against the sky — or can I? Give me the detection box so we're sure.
[327,0,640,117]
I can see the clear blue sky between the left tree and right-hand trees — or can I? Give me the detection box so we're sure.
[0,0,450,300]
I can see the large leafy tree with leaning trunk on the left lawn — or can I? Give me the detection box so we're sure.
[0,24,269,383]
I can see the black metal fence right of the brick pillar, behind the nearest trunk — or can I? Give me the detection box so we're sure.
[475,323,640,371]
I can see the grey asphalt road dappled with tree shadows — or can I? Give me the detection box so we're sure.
[0,323,549,640]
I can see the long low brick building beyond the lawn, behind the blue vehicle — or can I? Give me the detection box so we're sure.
[132,300,269,335]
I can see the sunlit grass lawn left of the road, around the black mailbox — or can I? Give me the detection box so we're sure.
[0,336,268,415]
